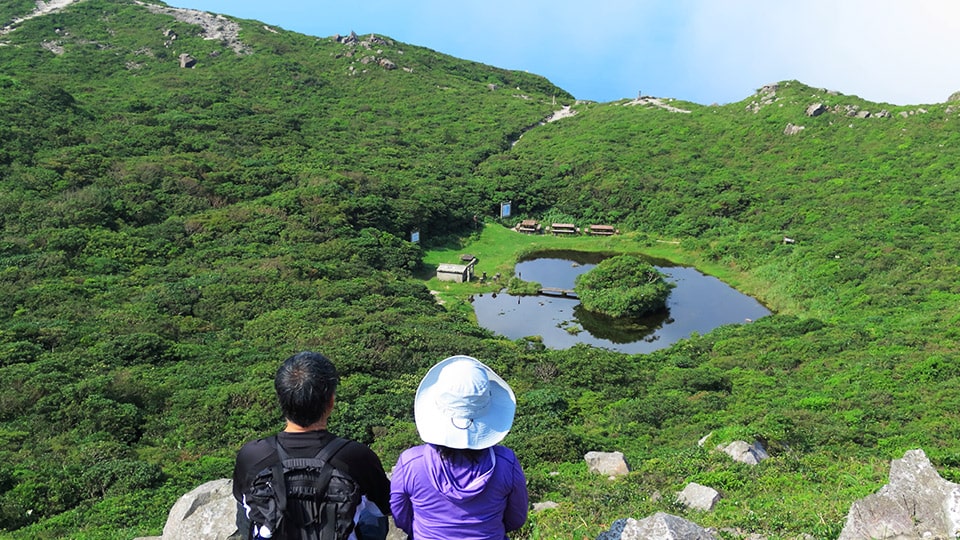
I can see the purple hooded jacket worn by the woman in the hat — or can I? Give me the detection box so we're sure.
[390,444,528,540]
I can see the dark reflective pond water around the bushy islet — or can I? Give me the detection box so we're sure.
[473,251,770,354]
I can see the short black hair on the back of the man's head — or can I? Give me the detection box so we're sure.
[273,351,339,427]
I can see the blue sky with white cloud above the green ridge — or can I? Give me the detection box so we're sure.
[167,0,960,105]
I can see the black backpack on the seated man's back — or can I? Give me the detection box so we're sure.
[246,437,360,540]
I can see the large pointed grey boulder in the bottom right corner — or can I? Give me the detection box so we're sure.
[837,450,960,540]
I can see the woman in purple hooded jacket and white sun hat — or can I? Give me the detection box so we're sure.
[390,356,528,540]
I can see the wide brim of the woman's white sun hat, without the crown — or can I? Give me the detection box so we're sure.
[413,356,517,450]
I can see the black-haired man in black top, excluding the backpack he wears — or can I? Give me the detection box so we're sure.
[233,352,390,538]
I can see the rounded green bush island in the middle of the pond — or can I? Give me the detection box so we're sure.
[574,255,673,317]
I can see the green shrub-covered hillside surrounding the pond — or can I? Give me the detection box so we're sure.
[0,0,960,539]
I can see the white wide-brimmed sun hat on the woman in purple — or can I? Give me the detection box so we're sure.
[413,356,517,450]
